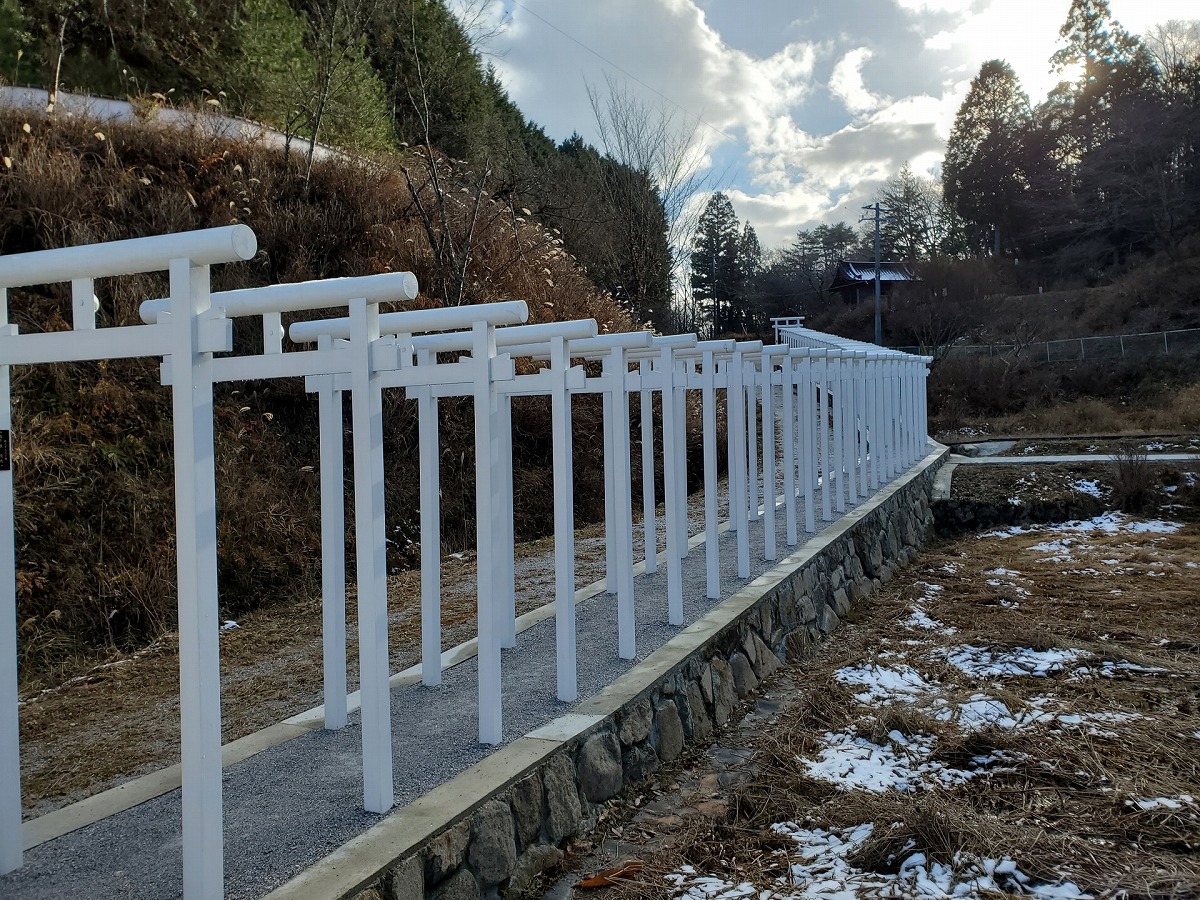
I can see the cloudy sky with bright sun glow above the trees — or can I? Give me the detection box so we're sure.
[455,0,1200,247]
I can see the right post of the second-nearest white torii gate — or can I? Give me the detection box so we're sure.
[349,299,395,812]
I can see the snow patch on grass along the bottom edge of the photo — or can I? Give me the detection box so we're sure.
[667,822,1091,900]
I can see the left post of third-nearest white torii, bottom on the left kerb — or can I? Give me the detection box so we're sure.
[316,343,347,730]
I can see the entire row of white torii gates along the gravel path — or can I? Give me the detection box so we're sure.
[0,226,926,899]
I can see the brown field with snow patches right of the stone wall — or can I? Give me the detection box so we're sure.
[545,466,1200,900]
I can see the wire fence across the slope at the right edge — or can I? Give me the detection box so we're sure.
[893,328,1200,362]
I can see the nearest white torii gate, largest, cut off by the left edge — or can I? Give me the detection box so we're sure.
[0,226,257,899]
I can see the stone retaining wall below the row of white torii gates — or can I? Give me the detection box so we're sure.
[342,457,938,900]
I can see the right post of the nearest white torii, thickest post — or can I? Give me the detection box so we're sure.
[169,259,224,900]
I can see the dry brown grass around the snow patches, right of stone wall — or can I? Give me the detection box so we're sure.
[590,501,1200,899]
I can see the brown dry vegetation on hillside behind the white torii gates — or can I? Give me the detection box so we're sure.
[0,110,634,682]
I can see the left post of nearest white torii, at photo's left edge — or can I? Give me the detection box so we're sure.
[0,288,24,875]
